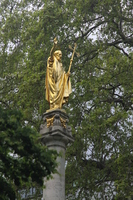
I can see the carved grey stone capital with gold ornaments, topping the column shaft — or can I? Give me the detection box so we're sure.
[40,109,74,146]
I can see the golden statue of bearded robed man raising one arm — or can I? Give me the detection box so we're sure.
[45,38,73,109]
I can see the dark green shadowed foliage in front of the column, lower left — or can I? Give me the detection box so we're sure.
[0,106,57,200]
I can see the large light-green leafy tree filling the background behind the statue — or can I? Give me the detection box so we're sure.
[0,0,133,200]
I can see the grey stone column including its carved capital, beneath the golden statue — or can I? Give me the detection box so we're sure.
[40,109,73,200]
